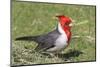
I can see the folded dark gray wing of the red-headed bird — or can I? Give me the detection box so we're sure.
[35,29,60,51]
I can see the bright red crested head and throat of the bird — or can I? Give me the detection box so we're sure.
[56,15,72,42]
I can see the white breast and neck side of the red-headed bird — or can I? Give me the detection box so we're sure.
[47,23,68,51]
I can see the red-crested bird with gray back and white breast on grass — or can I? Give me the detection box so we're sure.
[15,15,72,53]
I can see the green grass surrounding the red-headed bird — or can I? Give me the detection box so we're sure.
[11,1,96,65]
